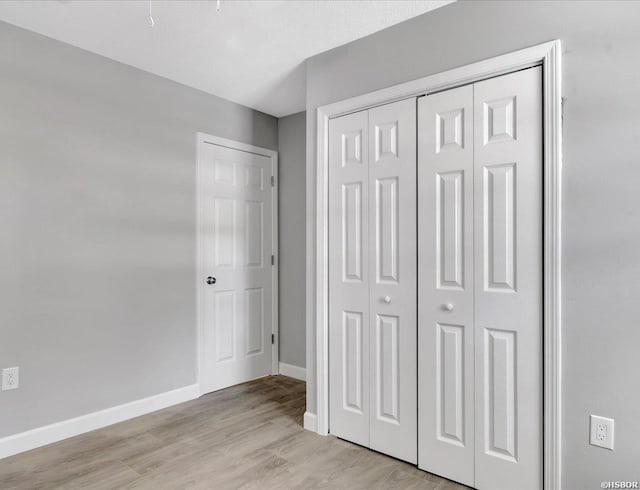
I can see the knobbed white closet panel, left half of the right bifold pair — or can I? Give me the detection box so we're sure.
[418,85,474,485]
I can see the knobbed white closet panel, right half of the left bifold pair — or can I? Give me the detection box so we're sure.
[368,99,417,463]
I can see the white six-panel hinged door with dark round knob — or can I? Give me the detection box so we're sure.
[199,143,273,392]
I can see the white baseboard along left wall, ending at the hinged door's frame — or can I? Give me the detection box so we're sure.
[0,384,200,459]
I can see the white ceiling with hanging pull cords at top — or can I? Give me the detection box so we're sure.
[0,0,452,116]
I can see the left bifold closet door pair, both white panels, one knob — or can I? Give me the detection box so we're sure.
[329,99,417,463]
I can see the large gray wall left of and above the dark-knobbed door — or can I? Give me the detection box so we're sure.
[0,23,278,437]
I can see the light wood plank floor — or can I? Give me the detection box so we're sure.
[0,376,467,490]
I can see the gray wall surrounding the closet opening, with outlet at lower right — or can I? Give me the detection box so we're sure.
[307,1,640,490]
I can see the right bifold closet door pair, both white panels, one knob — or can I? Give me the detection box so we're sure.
[418,68,543,490]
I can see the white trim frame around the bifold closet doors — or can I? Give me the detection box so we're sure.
[312,40,562,490]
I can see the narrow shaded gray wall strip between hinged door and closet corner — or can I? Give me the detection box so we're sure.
[278,112,306,367]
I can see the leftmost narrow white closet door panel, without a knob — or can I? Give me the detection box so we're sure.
[329,111,369,446]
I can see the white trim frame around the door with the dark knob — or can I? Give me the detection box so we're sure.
[195,133,280,395]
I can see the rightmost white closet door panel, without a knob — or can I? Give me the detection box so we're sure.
[474,67,543,490]
